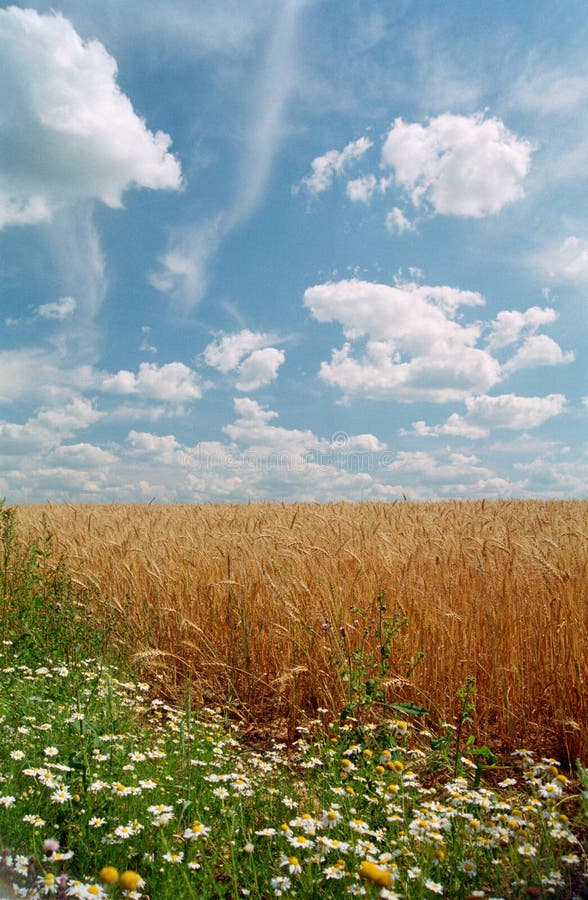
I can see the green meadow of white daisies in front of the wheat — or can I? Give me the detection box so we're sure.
[0,506,588,900]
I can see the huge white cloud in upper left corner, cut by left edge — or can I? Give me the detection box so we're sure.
[0,6,181,228]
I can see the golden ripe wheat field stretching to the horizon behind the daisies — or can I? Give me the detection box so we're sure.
[19,501,588,762]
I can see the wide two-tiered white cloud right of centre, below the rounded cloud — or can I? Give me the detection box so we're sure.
[304,279,500,403]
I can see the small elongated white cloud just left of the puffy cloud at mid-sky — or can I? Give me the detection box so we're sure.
[101,362,203,405]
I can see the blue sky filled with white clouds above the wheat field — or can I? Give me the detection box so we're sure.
[0,0,588,503]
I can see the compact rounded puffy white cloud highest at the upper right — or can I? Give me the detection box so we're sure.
[382,113,532,217]
